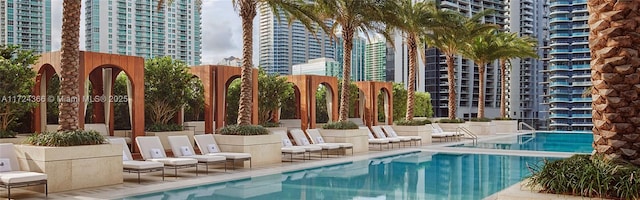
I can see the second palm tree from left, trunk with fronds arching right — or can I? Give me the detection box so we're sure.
[232,0,320,125]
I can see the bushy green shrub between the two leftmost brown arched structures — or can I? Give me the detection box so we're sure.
[144,56,194,149]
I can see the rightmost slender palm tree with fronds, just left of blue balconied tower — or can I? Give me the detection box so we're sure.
[496,33,538,118]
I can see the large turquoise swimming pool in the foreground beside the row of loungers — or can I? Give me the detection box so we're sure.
[125,152,543,200]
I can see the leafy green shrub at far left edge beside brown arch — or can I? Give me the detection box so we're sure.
[0,45,38,144]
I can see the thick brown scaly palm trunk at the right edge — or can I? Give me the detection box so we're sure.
[587,0,640,165]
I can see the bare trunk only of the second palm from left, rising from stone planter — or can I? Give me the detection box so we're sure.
[238,0,257,125]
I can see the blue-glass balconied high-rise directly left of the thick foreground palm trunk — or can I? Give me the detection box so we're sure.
[545,0,593,131]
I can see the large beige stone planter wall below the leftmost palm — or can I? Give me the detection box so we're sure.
[15,144,122,193]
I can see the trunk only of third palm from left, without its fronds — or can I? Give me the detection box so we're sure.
[338,26,362,122]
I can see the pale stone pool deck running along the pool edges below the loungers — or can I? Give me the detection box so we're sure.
[0,133,587,200]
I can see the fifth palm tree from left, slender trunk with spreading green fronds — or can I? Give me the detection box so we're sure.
[424,10,496,119]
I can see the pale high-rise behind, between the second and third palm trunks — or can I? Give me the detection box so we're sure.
[259,5,335,75]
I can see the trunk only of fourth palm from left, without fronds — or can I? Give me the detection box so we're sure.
[405,34,418,120]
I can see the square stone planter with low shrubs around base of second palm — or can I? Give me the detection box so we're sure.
[213,125,282,166]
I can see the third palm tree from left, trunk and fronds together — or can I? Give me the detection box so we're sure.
[304,0,391,121]
